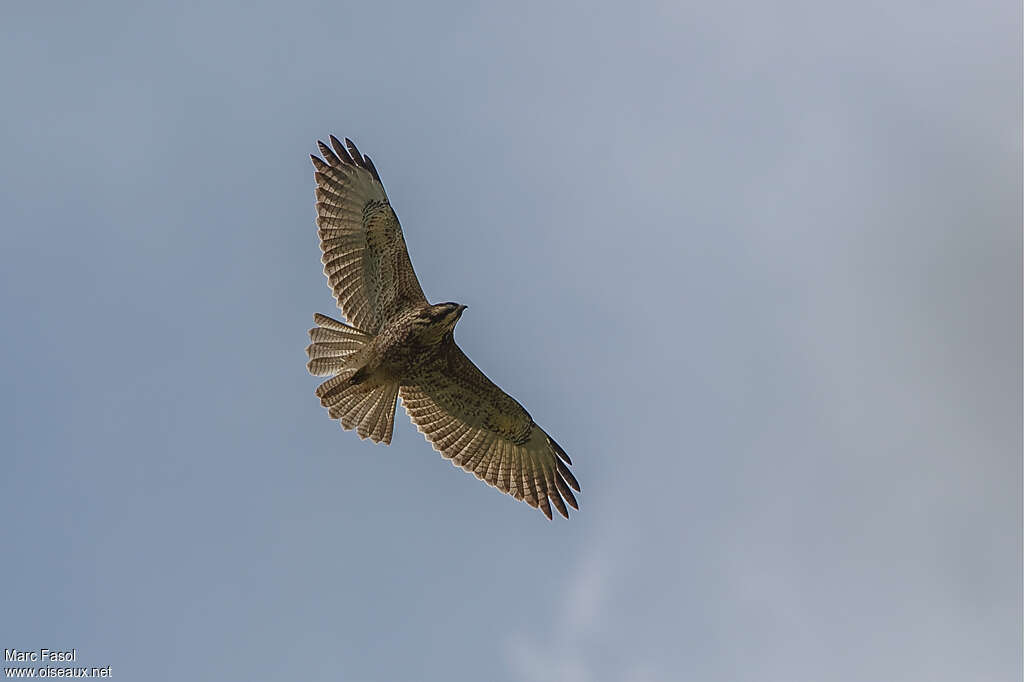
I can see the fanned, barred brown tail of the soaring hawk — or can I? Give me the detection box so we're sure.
[306,313,398,443]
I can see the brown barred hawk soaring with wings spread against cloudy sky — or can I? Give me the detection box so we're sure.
[306,135,580,519]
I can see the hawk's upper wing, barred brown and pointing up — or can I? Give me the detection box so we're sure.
[311,135,427,334]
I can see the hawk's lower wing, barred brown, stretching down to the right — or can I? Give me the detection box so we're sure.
[398,337,580,518]
